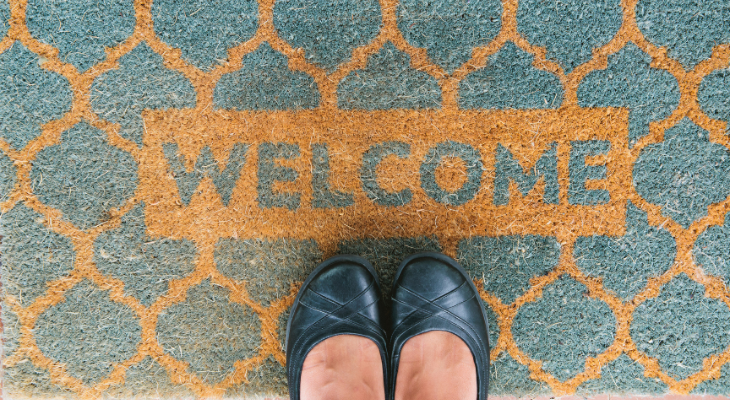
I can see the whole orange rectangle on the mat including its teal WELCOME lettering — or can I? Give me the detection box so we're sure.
[139,108,631,237]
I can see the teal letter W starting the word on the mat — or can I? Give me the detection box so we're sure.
[162,143,248,206]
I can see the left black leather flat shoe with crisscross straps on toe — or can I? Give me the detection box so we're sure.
[286,255,388,400]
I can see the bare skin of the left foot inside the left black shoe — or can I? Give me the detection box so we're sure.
[300,335,385,400]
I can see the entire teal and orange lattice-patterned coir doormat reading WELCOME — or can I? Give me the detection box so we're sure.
[0,0,730,398]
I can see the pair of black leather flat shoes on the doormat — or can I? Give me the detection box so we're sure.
[286,253,489,400]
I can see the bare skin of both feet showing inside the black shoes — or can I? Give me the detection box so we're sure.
[300,331,477,400]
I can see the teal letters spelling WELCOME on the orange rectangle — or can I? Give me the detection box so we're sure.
[163,140,611,210]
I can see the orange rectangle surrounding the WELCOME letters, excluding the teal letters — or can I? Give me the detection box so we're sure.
[138,108,631,246]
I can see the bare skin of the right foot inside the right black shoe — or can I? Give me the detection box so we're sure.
[395,331,477,400]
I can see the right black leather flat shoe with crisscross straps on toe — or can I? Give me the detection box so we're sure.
[387,253,489,400]
